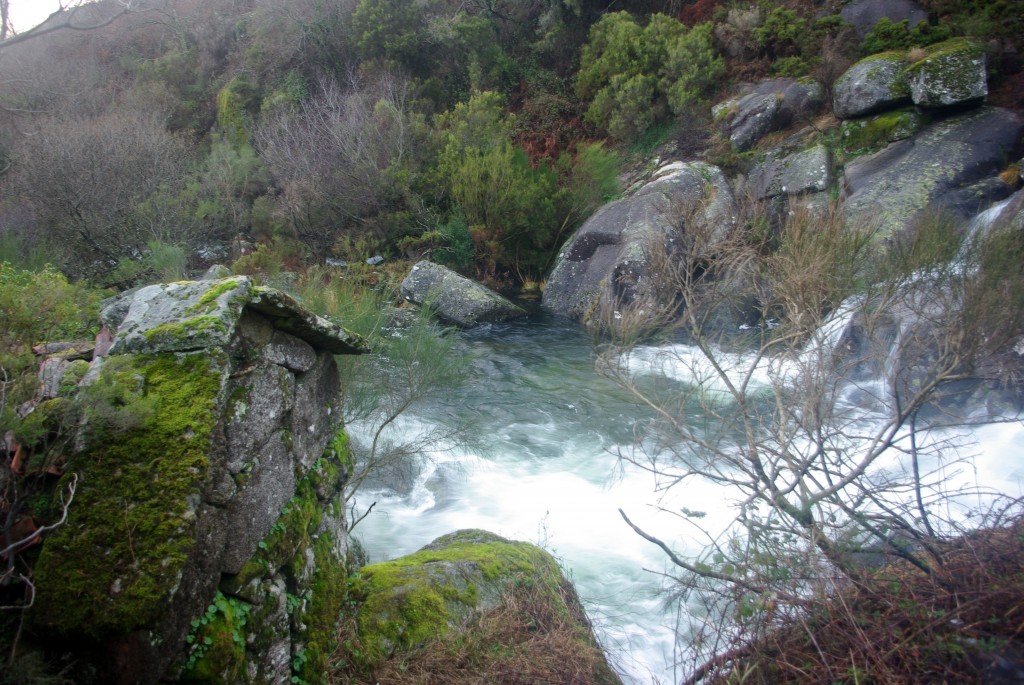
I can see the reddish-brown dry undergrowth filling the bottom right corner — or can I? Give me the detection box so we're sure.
[701,518,1024,685]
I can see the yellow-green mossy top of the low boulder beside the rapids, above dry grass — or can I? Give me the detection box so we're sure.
[352,530,620,685]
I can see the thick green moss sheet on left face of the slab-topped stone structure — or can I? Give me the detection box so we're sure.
[32,352,224,638]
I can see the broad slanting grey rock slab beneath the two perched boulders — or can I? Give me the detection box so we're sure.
[843,109,1024,236]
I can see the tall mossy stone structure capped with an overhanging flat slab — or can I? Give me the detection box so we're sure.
[28,277,366,683]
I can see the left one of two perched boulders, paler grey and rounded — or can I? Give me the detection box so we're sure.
[833,52,910,119]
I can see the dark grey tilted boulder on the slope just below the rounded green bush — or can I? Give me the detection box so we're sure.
[712,79,823,151]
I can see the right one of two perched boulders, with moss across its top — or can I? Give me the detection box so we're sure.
[904,38,988,108]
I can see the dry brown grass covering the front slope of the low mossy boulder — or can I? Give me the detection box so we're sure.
[329,583,620,685]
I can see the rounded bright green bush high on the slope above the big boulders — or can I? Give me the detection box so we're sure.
[577,12,723,140]
